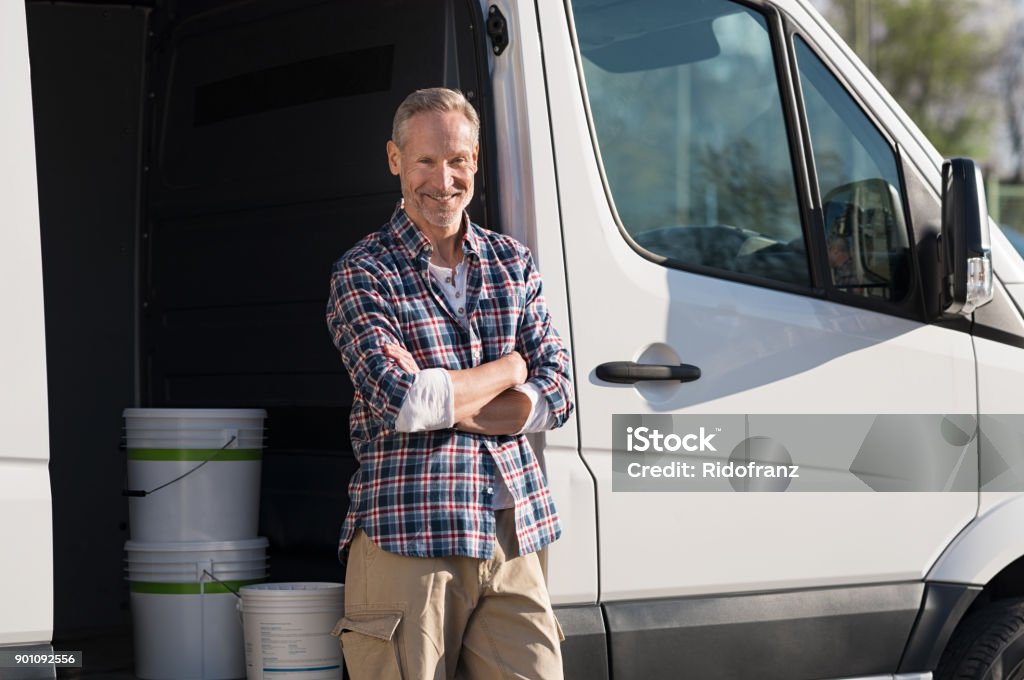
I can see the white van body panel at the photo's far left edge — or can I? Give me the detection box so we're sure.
[0,2,53,645]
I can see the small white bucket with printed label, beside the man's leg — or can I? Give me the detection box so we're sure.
[238,583,345,680]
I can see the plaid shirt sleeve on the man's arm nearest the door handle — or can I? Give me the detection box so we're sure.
[516,249,574,428]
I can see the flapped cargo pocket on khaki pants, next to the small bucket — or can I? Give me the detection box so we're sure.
[331,611,402,680]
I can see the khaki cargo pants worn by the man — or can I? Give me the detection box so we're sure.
[334,510,563,680]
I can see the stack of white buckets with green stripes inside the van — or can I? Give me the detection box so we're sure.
[124,409,267,680]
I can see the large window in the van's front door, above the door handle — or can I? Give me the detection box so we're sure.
[572,0,810,285]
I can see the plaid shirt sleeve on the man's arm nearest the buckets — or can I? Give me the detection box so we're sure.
[327,258,415,430]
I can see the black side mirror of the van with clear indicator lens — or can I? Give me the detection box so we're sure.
[939,158,992,316]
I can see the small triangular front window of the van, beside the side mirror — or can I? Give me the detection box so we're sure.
[796,38,910,301]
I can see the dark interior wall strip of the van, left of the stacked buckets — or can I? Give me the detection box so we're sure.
[27,3,147,631]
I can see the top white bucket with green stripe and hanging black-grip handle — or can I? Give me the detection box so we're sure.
[124,409,266,543]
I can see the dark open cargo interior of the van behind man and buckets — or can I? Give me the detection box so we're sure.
[29,0,483,635]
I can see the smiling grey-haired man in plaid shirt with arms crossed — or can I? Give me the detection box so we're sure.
[328,88,572,680]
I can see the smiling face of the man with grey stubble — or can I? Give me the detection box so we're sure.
[387,112,478,231]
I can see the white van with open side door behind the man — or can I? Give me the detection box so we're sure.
[6,0,1024,680]
